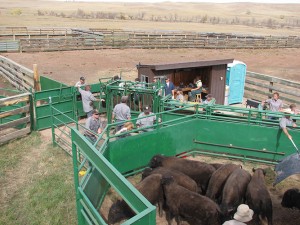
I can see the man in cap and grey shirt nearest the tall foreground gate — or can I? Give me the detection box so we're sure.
[84,109,102,143]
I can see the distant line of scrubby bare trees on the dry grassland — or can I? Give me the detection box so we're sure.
[37,9,300,28]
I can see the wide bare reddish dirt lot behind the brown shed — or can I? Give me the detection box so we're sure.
[2,49,300,85]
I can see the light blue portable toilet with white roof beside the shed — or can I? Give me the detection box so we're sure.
[225,60,247,105]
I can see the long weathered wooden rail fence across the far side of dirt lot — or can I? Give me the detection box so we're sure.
[0,28,300,52]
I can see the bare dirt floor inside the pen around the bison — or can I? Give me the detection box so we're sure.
[101,156,300,225]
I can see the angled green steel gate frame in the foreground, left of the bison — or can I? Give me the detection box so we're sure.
[71,129,156,225]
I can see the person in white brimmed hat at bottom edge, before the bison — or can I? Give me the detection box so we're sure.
[223,204,253,225]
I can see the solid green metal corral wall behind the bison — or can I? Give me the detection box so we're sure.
[108,118,300,173]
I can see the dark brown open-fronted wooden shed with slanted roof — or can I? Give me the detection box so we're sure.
[137,59,233,104]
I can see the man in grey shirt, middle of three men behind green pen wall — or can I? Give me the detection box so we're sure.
[112,96,131,131]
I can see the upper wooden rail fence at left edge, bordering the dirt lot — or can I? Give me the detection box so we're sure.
[0,56,34,92]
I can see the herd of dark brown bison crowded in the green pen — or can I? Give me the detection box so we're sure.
[108,155,299,225]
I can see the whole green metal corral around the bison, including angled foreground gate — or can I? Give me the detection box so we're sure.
[71,103,300,225]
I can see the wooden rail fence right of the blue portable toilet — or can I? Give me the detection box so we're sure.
[245,71,300,105]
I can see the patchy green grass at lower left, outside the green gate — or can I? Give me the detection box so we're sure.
[0,134,77,225]
